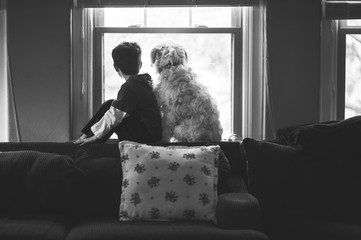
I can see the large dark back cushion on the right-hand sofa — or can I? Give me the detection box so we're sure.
[243,139,361,216]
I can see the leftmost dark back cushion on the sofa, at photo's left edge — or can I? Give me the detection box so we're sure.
[0,150,83,215]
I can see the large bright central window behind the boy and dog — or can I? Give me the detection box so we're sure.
[94,7,241,138]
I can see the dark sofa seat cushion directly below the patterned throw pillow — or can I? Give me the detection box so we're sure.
[67,219,268,240]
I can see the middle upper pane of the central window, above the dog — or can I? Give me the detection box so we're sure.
[146,7,190,27]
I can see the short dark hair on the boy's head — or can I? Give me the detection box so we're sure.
[112,42,142,75]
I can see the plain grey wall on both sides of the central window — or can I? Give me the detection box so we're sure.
[4,0,321,141]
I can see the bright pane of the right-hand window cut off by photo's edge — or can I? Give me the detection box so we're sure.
[345,34,361,118]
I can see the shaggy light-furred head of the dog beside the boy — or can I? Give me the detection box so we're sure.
[150,40,188,73]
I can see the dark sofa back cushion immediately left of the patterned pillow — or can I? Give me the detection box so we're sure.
[76,144,123,218]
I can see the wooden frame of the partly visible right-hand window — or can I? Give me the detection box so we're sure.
[320,19,361,122]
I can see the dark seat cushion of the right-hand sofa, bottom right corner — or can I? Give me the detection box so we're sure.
[266,216,361,240]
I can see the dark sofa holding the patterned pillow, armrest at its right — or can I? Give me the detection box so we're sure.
[0,141,268,240]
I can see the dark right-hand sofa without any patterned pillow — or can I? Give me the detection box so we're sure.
[242,116,361,240]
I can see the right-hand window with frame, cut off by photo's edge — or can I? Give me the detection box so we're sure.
[321,20,361,120]
